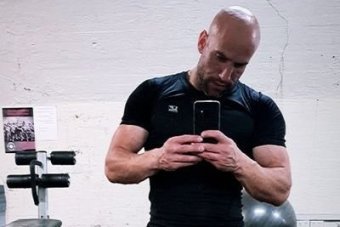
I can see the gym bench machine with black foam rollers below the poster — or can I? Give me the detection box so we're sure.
[6,151,76,227]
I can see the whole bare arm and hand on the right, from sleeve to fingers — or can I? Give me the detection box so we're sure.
[200,131,291,205]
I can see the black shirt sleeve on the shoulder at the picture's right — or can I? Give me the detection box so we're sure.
[253,93,286,147]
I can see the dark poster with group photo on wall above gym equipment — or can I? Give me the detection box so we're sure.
[2,107,35,153]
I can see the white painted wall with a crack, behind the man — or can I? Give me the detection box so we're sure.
[0,0,340,227]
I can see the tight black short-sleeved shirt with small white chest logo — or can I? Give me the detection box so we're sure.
[121,72,285,227]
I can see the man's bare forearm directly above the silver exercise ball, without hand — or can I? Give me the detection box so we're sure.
[235,151,291,205]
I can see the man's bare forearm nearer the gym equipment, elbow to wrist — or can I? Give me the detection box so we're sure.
[105,149,159,184]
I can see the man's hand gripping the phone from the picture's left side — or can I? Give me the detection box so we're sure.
[158,135,204,171]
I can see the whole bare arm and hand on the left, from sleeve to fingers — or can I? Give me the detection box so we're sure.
[105,124,204,184]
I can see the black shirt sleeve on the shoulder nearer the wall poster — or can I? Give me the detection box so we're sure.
[121,80,157,131]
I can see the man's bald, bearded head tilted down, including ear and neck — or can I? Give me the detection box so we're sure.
[190,6,260,97]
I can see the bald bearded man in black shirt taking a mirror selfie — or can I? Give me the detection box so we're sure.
[105,7,291,227]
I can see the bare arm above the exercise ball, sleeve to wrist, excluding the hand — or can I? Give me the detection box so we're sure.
[235,145,292,205]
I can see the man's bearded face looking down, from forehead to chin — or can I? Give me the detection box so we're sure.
[196,27,256,97]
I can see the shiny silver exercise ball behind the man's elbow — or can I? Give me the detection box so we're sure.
[242,191,297,227]
